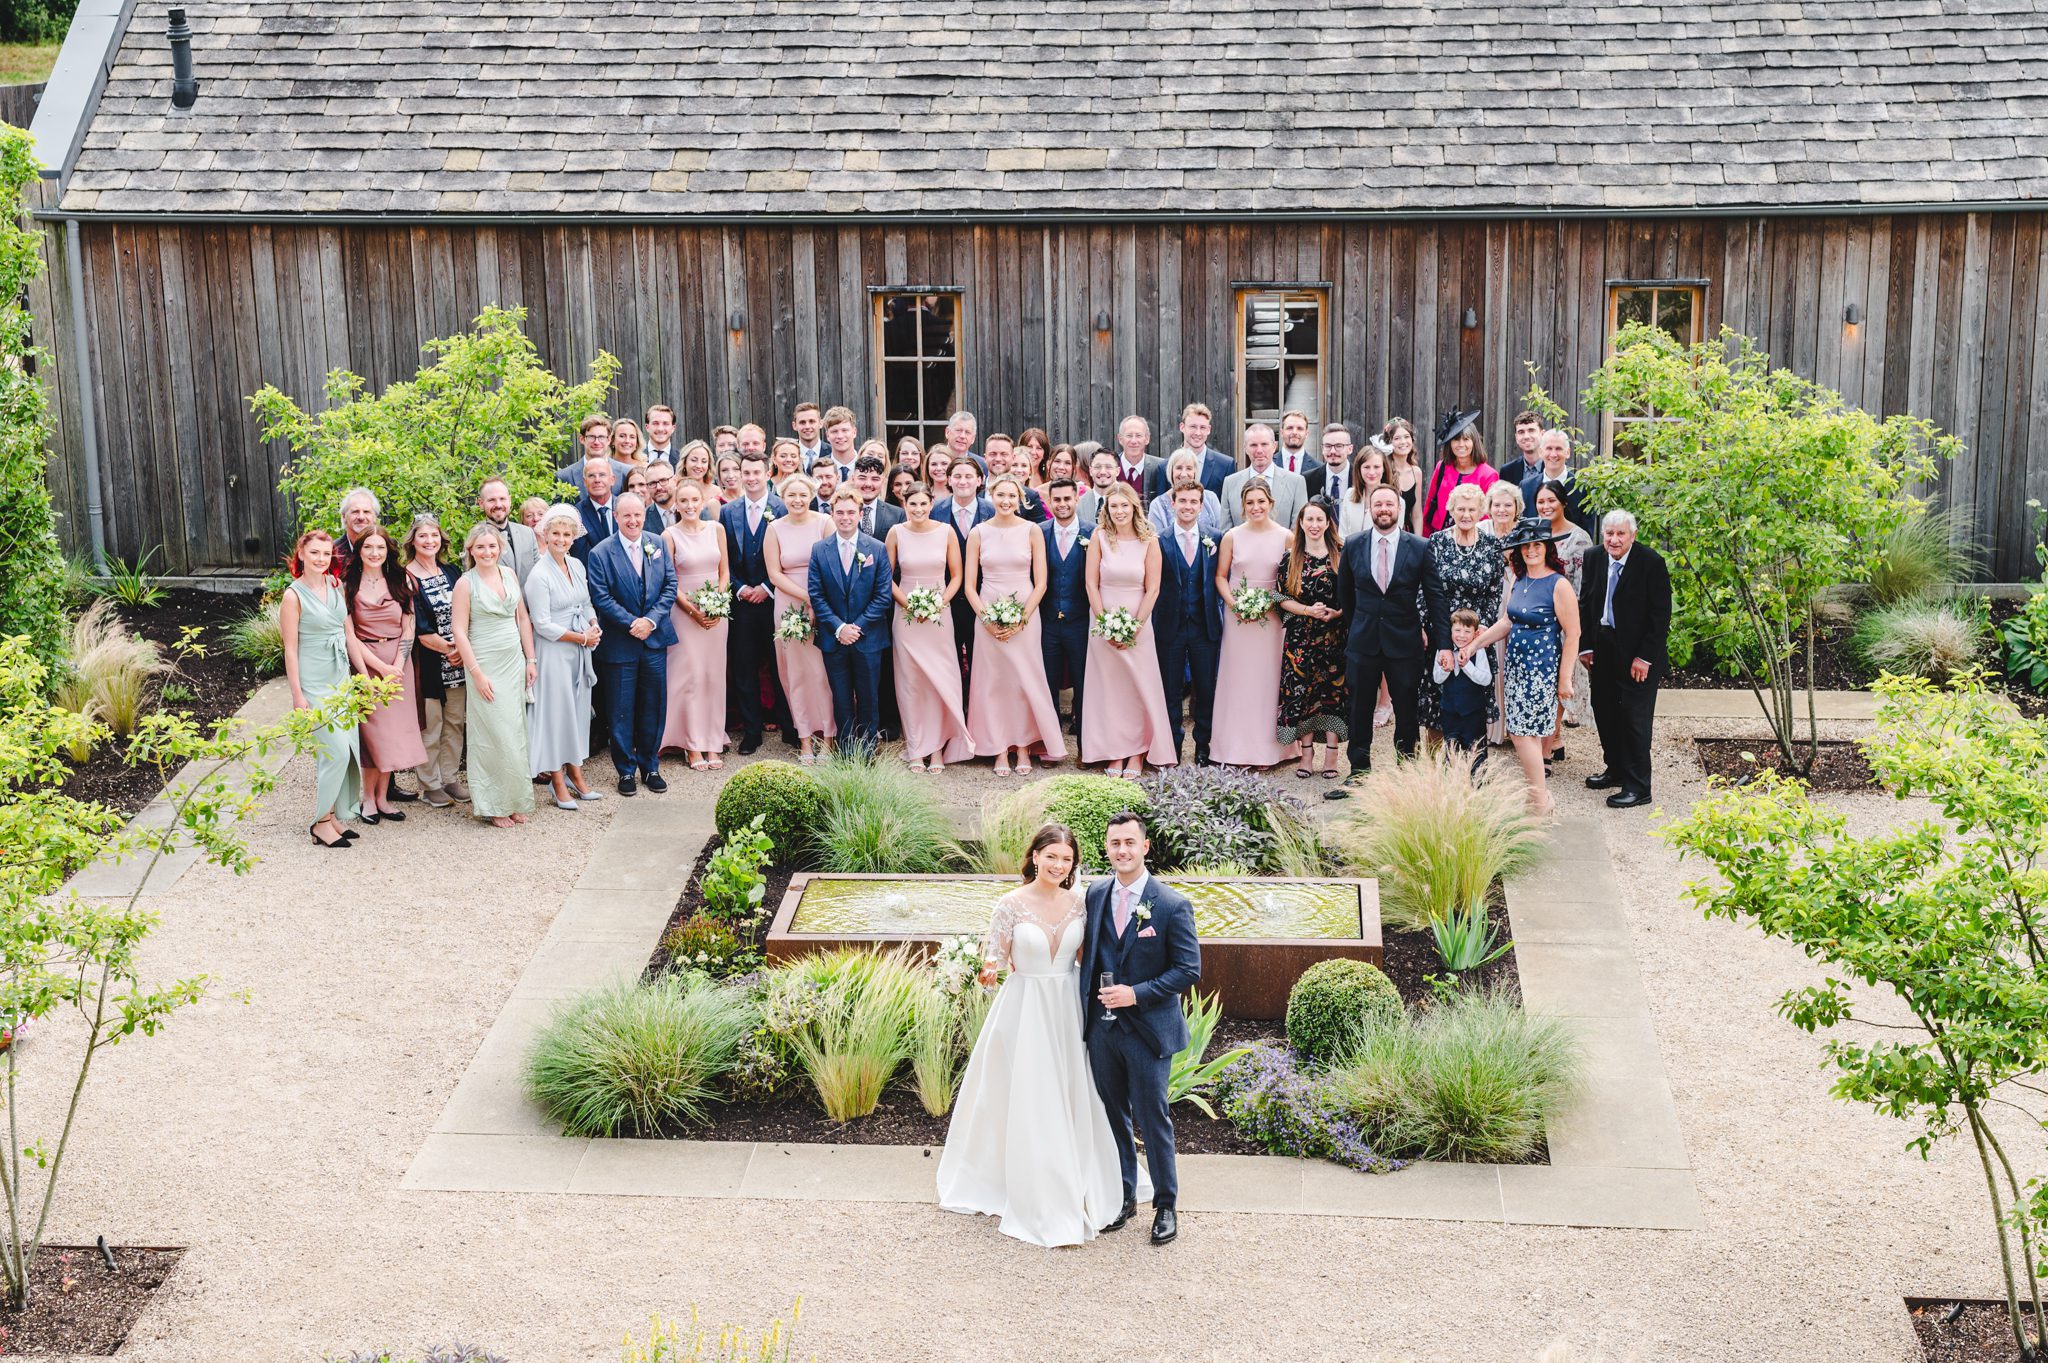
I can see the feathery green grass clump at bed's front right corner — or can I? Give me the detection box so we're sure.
[1323,988,1585,1162]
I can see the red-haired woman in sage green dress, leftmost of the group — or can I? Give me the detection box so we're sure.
[276,530,362,847]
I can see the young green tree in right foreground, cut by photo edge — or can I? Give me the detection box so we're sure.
[1663,671,2048,1359]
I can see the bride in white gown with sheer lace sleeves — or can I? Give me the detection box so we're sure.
[938,823,1151,1246]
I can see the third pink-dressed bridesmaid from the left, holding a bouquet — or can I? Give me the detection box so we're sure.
[887,485,975,772]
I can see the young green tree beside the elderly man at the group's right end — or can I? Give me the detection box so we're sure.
[1579,323,1962,772]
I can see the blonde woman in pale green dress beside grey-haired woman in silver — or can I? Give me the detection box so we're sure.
[453,520,535,829]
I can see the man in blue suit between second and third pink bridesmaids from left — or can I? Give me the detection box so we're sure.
[811,487,895,751]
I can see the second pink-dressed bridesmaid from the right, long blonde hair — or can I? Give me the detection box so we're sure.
[1081,483,1180,780]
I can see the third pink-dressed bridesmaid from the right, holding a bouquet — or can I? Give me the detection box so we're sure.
[965,475,1067,776]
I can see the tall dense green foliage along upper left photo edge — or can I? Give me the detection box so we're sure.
[0,125,66,677]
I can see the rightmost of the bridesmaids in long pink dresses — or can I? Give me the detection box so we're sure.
[1208,479,1300,767]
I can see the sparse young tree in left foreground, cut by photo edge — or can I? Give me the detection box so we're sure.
[0,634,385,1310]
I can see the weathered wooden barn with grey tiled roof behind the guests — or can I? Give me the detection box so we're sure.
[33,0,2048,579]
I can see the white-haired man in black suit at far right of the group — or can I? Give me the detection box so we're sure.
[1579,510,1671,808]
